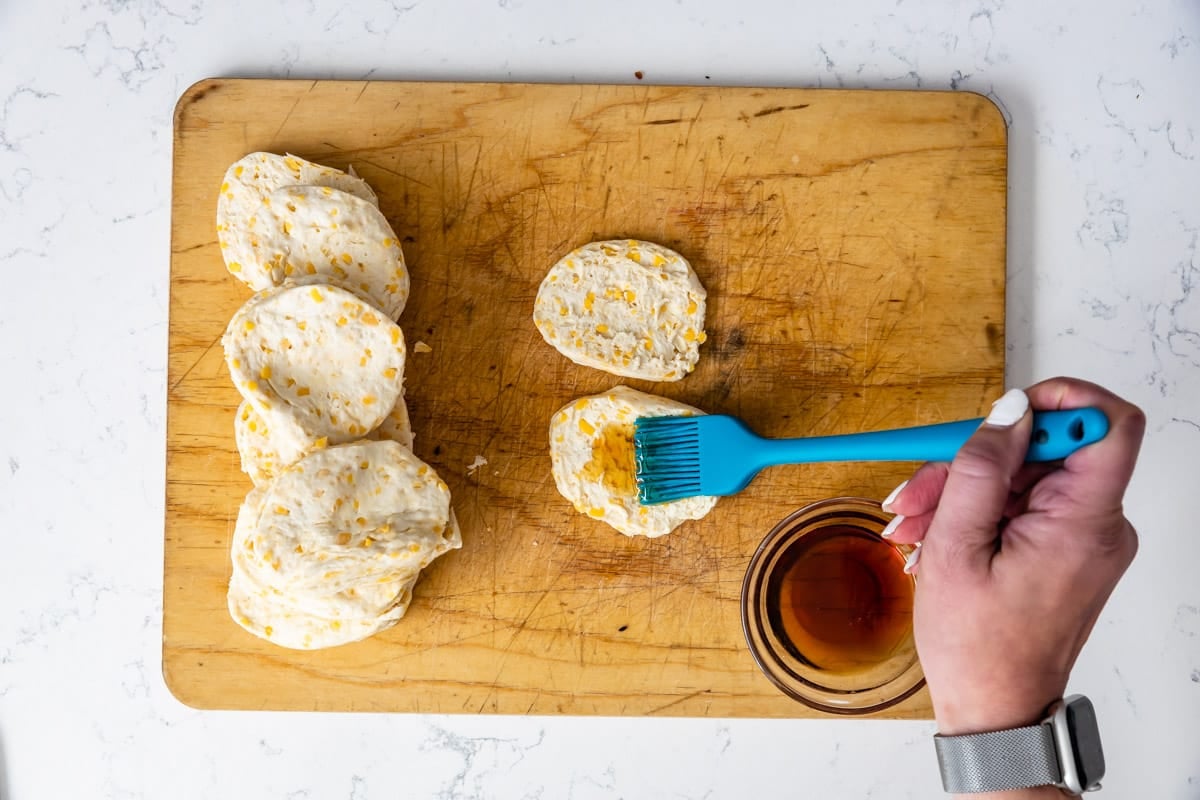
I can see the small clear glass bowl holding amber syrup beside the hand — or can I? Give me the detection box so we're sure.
[742,498,925,715]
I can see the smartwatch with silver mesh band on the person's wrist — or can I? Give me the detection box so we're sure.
[934,694,1104,794]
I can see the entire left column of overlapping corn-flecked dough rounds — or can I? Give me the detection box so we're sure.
[217,152,462,650]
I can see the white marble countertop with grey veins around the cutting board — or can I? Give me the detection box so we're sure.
[0,0,1200,800]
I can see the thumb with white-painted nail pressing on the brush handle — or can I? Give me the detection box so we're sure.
[922,389,1033,572]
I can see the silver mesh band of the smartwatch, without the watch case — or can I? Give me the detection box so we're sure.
[934,724,1062,794]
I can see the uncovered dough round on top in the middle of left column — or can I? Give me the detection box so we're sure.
[222,283,406,461]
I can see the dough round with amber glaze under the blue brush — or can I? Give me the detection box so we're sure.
[550,386,716,539]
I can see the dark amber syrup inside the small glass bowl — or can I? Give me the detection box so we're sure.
[767,524,913,673]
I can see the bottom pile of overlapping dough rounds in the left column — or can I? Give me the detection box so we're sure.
[228,441,462,649]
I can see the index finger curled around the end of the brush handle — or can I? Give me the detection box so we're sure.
[1026,378,1146,509]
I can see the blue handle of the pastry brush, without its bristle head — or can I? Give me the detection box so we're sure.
[763,408,1109,465]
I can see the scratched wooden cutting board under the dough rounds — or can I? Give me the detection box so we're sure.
[163,80,1006,717]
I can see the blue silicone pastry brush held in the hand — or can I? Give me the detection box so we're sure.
[634,408,1109,505]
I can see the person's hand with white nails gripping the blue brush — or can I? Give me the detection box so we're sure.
[884,378,1145,735]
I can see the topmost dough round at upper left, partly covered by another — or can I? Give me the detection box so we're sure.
[217,152,379,291]
